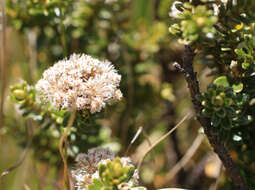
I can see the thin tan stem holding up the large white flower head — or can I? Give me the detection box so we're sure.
[58,106,76,190]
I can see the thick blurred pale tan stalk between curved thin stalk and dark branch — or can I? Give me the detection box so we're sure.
[165,134,204,181]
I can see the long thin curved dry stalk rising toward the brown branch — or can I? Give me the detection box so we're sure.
[137,113,191,171]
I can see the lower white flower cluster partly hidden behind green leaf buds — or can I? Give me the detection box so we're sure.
[71,148,139,190]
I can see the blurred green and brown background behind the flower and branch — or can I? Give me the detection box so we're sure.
[0,0,225,190]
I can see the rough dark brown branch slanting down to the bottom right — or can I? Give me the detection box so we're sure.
[175,46,248,190]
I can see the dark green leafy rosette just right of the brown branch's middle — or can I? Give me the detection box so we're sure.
[198,85,250,133]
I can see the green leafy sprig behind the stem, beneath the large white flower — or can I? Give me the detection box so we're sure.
[11,81,107,164]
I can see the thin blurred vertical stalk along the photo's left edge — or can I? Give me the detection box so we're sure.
[0,0,7,128]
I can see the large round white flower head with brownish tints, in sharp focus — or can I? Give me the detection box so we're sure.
[36,54,122,113]
